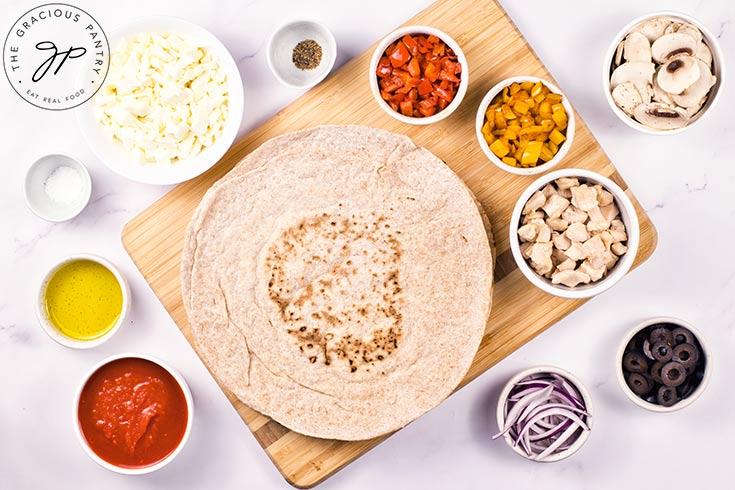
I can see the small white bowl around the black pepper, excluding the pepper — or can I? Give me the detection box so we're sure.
[267,20,337,89]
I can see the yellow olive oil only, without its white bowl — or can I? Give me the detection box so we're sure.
[44,259,123,340]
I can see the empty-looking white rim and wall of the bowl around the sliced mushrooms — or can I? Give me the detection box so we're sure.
[602,11,725,135]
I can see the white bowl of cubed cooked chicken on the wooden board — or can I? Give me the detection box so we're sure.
[510,169,640,299]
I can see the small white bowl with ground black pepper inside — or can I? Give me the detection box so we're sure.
[267,20,337,89]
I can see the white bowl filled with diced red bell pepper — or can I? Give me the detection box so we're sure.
[369,26,469,125]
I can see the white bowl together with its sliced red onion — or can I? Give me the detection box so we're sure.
[493,366,592,463]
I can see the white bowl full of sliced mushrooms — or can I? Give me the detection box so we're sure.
[604,12,724,134]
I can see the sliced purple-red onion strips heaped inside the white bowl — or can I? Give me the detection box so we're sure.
[493,373,591,461]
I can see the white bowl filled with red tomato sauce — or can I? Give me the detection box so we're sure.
[75,353,194,475]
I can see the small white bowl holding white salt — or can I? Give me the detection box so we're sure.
[25,153,92,222]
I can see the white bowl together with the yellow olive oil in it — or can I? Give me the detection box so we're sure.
[36,254,130,349]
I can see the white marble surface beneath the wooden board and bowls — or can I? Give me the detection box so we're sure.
[0,0,735,489]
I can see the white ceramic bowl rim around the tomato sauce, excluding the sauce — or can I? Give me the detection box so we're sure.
[73,353,194,475]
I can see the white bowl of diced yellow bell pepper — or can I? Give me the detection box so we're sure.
[475,76,574,175]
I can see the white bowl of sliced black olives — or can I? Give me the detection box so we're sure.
[616,317,712,412]
